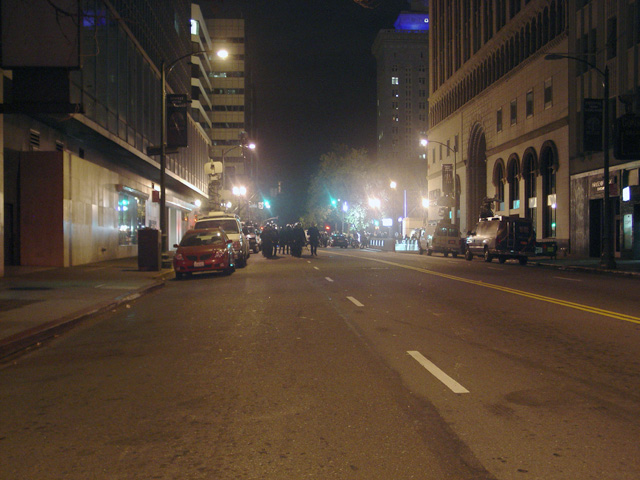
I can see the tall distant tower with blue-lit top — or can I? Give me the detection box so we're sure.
[372,1,429,230]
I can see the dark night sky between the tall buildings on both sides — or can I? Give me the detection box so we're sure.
[209,0,409,213]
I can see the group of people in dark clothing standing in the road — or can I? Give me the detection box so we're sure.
[260,223,320,258]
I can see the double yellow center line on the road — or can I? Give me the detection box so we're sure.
[338,254,640,325]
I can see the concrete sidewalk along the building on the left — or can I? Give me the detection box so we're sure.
[0,257,174,360]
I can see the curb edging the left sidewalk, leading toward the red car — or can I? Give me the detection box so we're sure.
[0,280,168,363]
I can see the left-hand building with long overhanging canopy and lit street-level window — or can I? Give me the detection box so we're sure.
[0,0,211,266]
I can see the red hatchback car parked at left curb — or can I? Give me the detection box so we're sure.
[173,228,236,279]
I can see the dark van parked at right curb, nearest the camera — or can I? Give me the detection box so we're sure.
[465,216,536,265]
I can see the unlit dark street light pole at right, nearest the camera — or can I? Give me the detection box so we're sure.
[544,53,617,270]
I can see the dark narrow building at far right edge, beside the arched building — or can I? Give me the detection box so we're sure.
[564,0,640,259]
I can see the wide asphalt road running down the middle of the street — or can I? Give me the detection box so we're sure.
[0,249,640,480]
